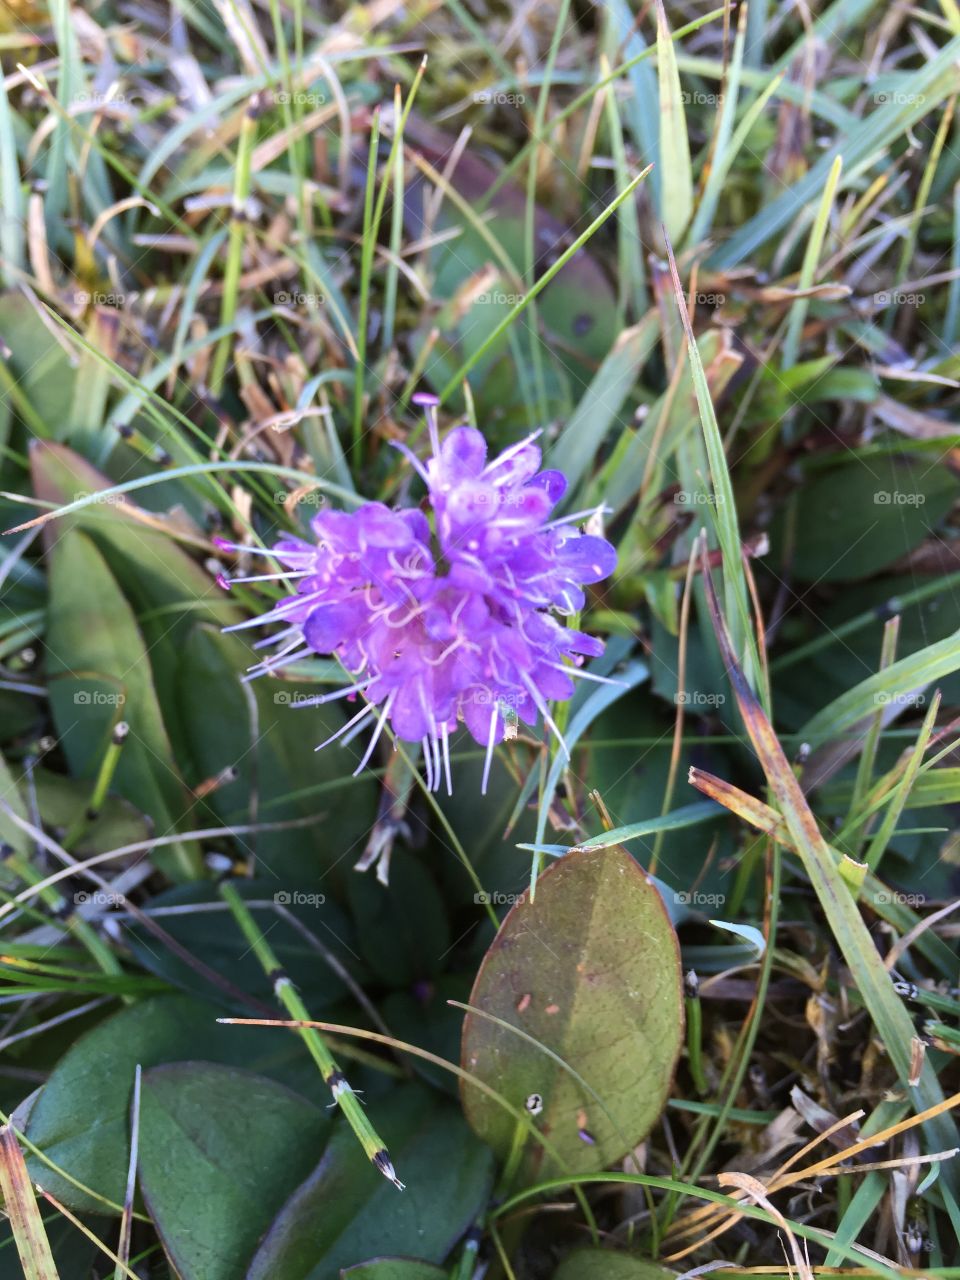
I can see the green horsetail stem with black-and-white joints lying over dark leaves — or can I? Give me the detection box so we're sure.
[220,881,403,1190]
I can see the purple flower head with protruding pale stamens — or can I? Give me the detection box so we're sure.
[220,397,617,792]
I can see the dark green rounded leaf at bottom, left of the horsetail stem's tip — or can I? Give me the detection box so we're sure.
[140,1062,332,1280]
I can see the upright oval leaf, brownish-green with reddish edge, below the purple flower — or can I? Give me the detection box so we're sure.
[462,849,684,1176]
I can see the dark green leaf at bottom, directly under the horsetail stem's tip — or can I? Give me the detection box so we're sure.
[247,1085,493,1280]
